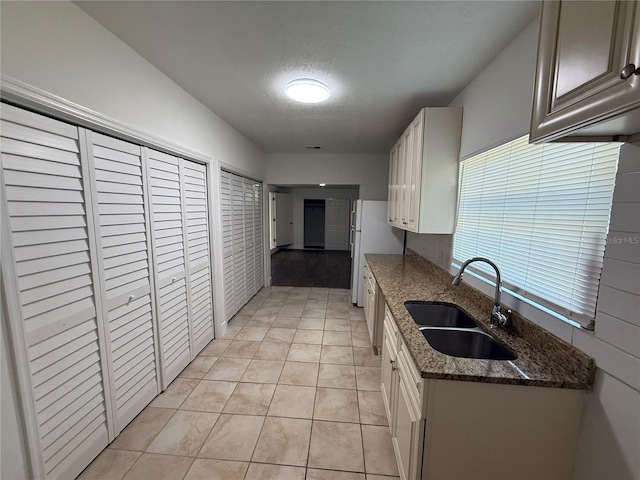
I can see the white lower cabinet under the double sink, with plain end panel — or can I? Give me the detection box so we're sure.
[382,307,584,480]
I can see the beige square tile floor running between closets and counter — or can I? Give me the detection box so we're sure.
[79,287,398,480]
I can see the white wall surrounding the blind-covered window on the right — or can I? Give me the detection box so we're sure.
[407,14,640,480]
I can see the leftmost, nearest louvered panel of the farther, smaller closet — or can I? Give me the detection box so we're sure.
[220,170,238,321]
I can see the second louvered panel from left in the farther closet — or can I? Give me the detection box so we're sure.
[231,175,247,311]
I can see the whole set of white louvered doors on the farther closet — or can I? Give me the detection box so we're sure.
[220,170,264,320]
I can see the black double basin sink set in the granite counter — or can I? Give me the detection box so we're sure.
[404,300,517,360]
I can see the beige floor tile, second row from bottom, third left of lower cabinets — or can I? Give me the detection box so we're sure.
[252,417,311,466]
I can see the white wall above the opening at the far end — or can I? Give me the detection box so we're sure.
[266,153,389,200]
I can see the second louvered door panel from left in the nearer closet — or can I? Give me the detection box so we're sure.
[87,132,159,435]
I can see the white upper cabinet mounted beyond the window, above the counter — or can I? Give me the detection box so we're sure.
[389,108,462,233]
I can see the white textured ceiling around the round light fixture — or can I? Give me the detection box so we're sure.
[76,0,539,153]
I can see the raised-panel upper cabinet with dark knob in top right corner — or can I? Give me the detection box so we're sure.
[530,1,640,142]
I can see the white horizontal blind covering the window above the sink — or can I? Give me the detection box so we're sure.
[453,136,620,329]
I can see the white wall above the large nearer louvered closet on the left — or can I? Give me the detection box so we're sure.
[0,2,264,177]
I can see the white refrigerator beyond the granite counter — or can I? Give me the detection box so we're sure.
[349,200,404,307]
